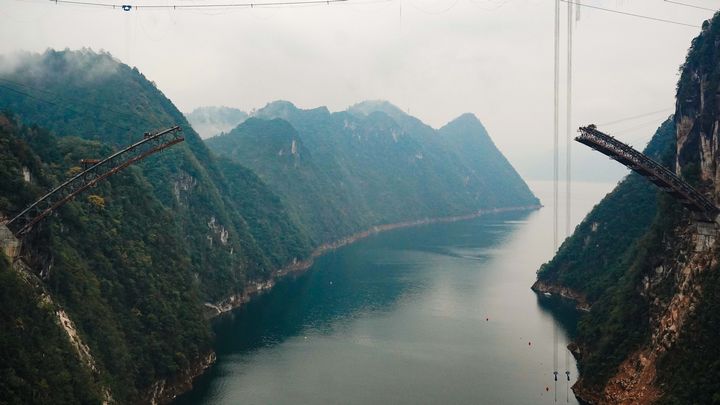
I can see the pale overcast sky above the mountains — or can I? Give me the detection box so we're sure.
[0,0,717,175]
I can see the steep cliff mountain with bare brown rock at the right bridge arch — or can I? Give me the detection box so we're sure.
[534,11,720,404]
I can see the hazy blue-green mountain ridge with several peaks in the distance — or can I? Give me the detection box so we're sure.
[206,101,538,243]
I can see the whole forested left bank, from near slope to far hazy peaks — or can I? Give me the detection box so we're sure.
[0,50,538,403]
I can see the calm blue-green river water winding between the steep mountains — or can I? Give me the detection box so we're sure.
[178,182,613,404]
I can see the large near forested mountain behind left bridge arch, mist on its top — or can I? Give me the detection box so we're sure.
[0,51,311,402]
